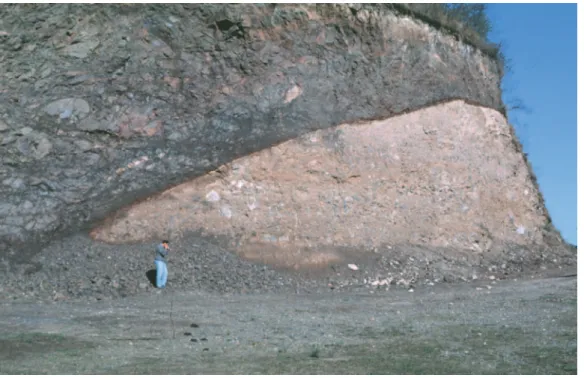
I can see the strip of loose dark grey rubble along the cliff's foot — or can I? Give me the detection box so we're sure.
[0,227,576,302]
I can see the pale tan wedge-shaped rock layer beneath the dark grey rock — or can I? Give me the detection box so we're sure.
[92,101,546,267]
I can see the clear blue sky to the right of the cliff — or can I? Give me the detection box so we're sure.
[487,4,577,244]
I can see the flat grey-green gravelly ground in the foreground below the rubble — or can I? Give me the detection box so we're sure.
[0,276,577,374]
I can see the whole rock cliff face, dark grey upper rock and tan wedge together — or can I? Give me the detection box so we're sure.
[0,4,562,286]
